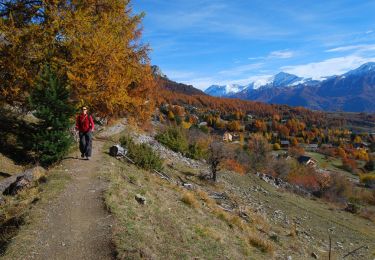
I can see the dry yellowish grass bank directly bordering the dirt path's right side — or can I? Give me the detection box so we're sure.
[104,149,270,259]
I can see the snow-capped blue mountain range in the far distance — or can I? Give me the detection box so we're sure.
[206,63,375,113]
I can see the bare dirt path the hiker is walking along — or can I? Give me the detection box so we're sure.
[10,141,113,260]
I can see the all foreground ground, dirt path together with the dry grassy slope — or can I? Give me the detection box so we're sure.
[0,115,375,259]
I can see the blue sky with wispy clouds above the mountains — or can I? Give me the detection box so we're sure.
[132,0,375,89]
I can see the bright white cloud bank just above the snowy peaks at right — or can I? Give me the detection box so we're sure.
[281,55,375,79]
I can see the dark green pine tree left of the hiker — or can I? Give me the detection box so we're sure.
[29,65,74,166]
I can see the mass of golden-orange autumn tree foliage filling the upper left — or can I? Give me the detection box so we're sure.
[0,0,154,118]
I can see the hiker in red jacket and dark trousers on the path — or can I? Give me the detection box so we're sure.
[76,106,94,160]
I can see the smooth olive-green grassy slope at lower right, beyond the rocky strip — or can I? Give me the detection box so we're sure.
[223,172,375,259]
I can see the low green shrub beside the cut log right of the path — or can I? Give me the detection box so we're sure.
[120,136,163,171]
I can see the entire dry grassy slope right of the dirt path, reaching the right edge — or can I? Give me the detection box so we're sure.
[103,133,375,259]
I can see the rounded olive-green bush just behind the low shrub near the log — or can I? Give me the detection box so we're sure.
[156,127,189,155]
